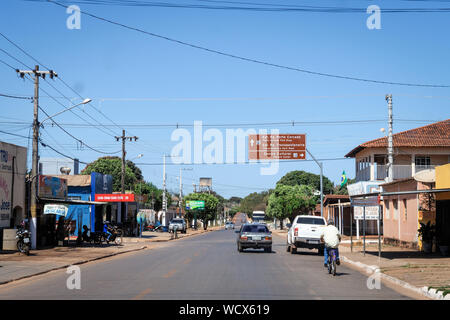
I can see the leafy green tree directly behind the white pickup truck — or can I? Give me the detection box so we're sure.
[266,184,317,227]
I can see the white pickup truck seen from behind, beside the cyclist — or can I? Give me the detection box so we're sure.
[286,215,327,254]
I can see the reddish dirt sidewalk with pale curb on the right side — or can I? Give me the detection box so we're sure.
[272,230,450,299]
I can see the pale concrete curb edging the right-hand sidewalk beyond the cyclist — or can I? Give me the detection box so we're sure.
[341,256,440,300]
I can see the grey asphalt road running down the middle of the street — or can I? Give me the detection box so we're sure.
[0,230,408,300]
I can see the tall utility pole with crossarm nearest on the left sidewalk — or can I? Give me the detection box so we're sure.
[16,65,58,249]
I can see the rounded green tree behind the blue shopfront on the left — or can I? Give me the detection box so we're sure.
[81,157,137,192]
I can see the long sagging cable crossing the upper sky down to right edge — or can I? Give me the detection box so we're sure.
[44,0,450,88]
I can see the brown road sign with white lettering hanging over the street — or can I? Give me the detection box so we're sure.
[248,134,306,160]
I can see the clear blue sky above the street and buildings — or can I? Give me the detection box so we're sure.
[0,0,450,197]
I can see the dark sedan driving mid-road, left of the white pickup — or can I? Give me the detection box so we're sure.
[236,223,272,252]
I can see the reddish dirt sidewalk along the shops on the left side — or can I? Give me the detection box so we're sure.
[0,227,223,285]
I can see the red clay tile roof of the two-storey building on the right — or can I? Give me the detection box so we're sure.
[345,119,450,158]
